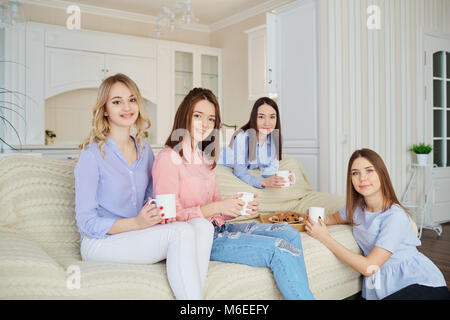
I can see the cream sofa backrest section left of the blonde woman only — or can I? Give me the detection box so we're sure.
[0,155,80,255]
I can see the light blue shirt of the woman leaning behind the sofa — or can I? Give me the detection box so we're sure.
[217,130,279,189]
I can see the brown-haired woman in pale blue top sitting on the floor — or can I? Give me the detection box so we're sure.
[306,149,449,300]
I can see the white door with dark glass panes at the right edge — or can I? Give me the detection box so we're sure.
[424,30,450,226]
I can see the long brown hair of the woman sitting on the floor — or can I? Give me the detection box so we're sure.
[346,148,409,225]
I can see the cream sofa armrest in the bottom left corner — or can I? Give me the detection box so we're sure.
[0,231,67,299]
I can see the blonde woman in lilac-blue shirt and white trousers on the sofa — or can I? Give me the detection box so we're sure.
[74,74,213,299]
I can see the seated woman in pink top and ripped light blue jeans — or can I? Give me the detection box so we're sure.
[152,88,314,299]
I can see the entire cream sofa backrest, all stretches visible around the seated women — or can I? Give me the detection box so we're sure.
[0,155,313,244]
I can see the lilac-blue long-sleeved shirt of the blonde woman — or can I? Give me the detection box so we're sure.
[74,137,153,239]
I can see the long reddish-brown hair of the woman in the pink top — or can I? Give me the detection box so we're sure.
[165,88,221,169]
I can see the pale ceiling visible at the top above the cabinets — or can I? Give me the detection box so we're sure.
[66,0,273,25]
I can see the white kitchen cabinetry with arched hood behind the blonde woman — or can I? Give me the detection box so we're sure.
[0,22,222,150]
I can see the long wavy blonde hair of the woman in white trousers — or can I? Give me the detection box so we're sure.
[78,73,151,156]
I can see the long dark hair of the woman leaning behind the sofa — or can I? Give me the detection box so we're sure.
[229,97,283,161]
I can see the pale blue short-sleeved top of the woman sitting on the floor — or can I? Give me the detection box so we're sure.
[339,205,446,300]
